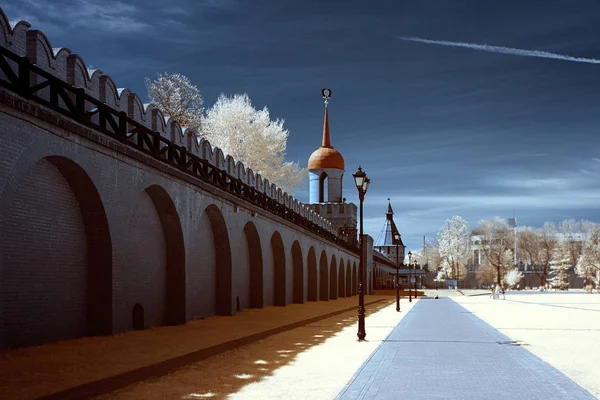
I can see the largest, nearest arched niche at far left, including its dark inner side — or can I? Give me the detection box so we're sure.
[0,156,113,348]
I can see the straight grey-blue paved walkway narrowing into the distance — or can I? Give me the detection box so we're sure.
[337,298,595,400]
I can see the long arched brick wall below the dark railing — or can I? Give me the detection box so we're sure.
[0,95,357,349]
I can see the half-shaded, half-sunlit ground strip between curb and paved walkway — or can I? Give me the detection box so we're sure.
[102,296,416,400]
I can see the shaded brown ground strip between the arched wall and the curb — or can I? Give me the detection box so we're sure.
[0,296,391,400]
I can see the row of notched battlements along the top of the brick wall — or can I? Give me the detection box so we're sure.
[0,8,335,234]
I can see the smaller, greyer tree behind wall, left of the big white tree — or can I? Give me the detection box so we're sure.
[146,73,204,131]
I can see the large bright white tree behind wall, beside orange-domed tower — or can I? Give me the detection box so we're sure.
[201,94,306,192]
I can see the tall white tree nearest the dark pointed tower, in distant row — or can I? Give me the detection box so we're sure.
[437,215,471,280]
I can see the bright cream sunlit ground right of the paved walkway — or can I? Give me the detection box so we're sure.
[453,291,600,398]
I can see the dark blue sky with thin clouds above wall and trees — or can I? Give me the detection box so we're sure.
[7,0,600,249]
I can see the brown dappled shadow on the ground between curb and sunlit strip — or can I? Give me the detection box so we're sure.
[101,298,394,399]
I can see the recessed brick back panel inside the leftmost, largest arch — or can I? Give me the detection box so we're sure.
[0,160,87,348]
